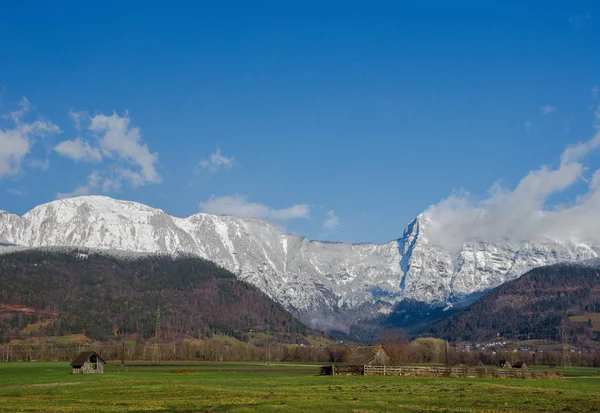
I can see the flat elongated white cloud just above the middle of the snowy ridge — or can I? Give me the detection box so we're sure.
[200,195,310,221]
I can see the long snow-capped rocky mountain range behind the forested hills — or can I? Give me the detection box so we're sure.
[0,196,600,329]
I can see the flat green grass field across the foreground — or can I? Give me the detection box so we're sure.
[0,362,600,413]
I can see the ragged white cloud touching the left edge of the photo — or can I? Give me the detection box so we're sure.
[0,98,61,178]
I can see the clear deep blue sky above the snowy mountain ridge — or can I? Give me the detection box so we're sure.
[0,1,600,242]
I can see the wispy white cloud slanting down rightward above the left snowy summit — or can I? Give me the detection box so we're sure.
[89,113,162,184]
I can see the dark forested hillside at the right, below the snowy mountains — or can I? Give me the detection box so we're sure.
[430,264,600,345]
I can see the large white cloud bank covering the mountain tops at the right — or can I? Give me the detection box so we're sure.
[423,127,600,252]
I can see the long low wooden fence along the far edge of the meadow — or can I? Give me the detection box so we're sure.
[360,366,562,379]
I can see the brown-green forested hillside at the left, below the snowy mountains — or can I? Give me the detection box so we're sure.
[0,250,307,342]
